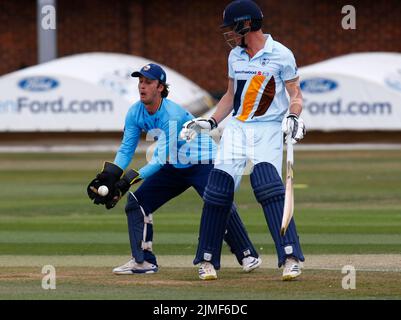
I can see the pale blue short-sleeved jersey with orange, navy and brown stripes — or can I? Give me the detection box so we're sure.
[228,34,298,122]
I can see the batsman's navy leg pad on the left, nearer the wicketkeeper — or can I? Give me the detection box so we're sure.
[194,169,234,269]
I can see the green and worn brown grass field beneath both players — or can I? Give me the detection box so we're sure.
[0,150,401,299]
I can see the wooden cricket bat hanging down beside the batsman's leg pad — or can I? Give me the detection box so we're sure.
[280,137,294,236]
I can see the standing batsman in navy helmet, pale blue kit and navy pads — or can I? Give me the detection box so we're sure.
[181,0,305,280]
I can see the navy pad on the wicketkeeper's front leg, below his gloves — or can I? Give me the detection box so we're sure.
[125,192,157,265]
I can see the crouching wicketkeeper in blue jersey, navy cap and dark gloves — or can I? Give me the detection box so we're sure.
[87,63,261,277]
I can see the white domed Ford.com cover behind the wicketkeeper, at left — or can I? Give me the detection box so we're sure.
[0,53,212,132]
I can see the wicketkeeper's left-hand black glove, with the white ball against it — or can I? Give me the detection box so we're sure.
[86,161,124,204]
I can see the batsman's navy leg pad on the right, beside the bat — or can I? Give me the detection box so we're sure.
[251,162,305,267]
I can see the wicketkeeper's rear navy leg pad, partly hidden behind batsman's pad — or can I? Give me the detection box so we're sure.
[224,204,259,264]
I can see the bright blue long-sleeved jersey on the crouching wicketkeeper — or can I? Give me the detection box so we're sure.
[114,99,217,179]
